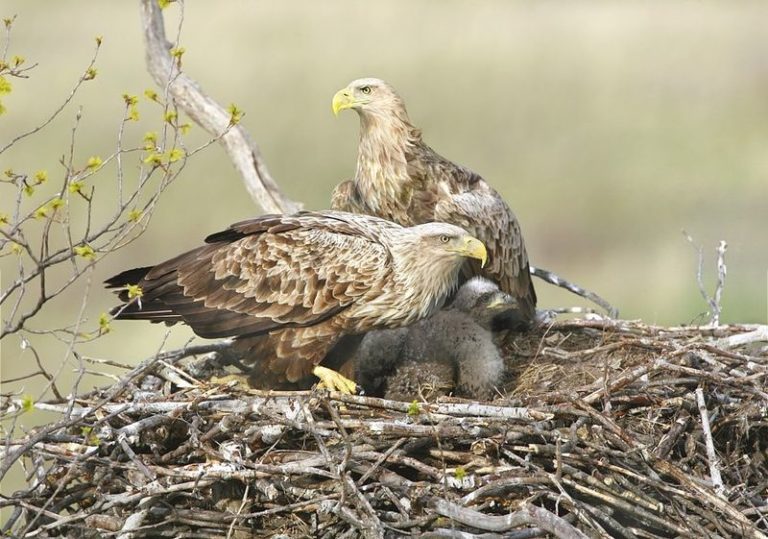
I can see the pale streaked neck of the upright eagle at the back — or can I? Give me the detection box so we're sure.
[355,111,421,220]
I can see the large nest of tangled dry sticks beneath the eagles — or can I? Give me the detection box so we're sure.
[3,321,768,538]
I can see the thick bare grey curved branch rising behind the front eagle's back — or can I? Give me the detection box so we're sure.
[141,0,301,213]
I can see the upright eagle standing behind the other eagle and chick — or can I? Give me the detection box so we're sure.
[331,78,536,328]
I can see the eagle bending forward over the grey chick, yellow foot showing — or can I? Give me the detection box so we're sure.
[106,211,487,390]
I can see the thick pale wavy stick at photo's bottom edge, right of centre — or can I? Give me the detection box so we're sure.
[433,498,587,539]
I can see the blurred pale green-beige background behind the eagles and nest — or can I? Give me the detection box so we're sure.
[0,0,768,502]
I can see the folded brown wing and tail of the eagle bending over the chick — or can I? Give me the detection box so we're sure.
[108,215,389,337]
